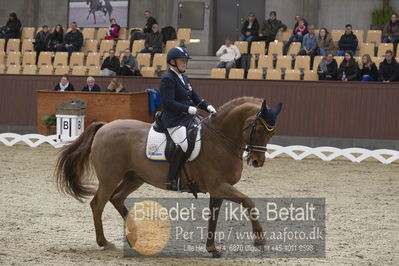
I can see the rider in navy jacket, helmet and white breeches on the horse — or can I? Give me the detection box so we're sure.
[161,47,216,191]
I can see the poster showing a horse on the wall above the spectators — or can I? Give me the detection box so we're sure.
[68,0,129,28]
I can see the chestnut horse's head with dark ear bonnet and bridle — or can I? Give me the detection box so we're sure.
[247,100,283,167]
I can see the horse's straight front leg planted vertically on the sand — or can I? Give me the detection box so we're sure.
[206,195,223,258]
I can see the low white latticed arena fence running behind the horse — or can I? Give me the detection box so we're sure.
[0,133,399,164]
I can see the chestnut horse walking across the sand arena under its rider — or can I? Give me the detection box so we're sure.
[56,97,282,257]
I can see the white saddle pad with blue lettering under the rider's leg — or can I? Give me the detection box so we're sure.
[145,125,201,162]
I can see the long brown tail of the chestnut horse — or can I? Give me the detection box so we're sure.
[55,122,105,201]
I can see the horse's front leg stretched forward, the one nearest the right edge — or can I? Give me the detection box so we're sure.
[210,183,266,246]
